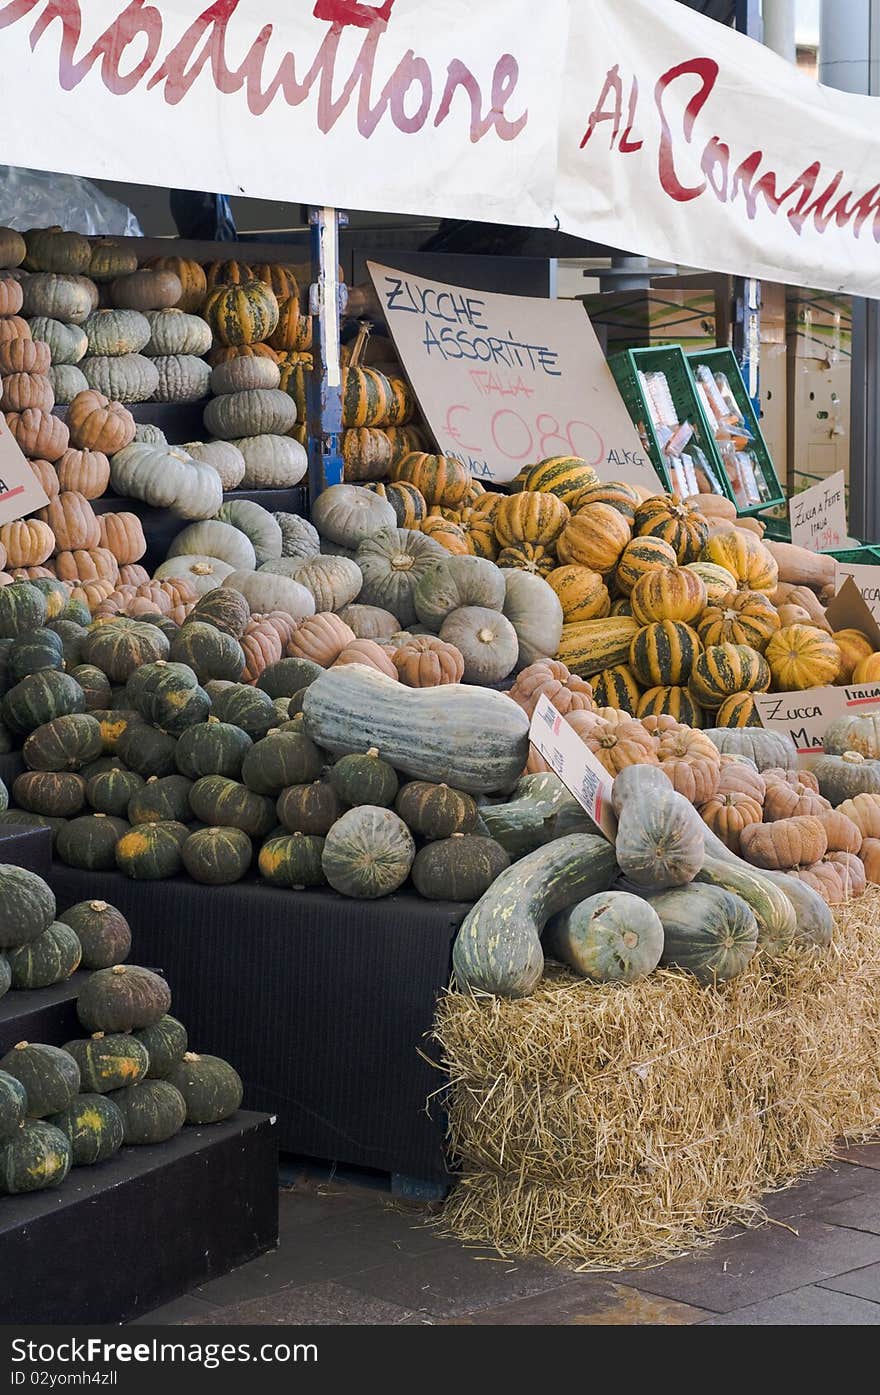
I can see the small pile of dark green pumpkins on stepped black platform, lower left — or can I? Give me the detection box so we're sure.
[0,865,243,1196]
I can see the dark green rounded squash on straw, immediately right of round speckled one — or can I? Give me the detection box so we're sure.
[650,884,757,983]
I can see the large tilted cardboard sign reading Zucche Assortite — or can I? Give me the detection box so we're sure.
[368,262,657,492]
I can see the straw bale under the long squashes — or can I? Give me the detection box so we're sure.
[435,887,880,1268]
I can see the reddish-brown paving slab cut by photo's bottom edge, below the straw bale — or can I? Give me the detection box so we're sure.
[443,1278,713,1327]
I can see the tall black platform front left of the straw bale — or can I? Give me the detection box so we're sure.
[50,862,469,1182]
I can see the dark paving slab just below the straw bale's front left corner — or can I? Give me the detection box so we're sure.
[340,1246,582,1317]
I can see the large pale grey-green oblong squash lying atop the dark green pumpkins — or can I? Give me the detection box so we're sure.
[303,664,529,794]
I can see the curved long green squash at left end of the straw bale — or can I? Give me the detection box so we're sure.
[452,833,618,997]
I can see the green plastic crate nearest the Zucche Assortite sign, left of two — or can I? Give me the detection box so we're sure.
[608,345,736,508]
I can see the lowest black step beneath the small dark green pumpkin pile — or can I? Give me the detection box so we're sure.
[0,1112,278,1327]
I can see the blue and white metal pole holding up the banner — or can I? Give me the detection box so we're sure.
[307,208,347,499]
